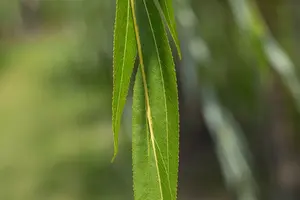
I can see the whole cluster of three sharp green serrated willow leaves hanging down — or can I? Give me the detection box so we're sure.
[112,0,180,200]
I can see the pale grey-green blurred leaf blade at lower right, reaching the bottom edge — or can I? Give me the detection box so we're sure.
[201,87,257,200]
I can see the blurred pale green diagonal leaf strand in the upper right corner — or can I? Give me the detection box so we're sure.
[229,0,300,112]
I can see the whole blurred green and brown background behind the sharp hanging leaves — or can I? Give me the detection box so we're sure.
[0,0,300,200]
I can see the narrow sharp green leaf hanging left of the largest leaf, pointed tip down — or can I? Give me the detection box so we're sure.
[112,0,136,159]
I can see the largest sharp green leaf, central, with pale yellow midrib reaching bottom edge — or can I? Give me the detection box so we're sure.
[131,0,179,200]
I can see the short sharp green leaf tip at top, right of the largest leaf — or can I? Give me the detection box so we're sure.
[154,0,181,59]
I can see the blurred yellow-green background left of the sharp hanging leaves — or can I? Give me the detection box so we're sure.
[0,0,132,200]
